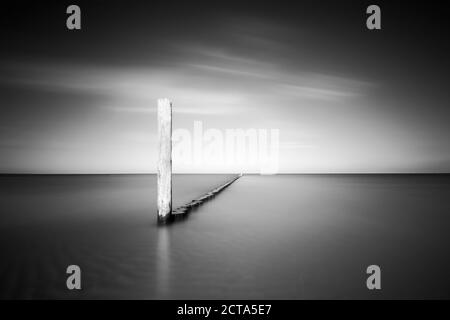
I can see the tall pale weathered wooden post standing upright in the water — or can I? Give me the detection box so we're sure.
[158,99,172,222]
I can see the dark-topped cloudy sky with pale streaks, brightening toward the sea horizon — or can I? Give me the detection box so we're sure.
[0,1,450,173]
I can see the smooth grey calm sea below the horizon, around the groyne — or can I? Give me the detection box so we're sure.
[0,175,450,299]
